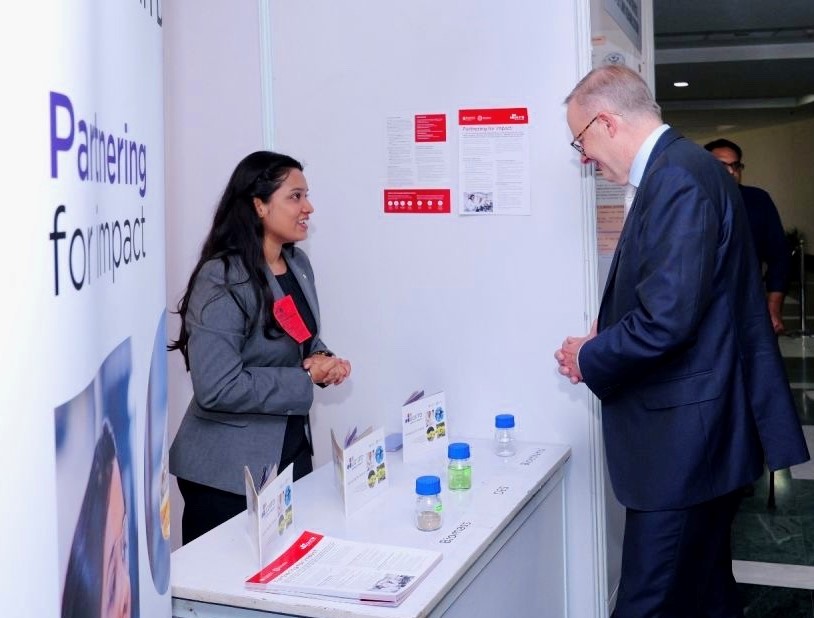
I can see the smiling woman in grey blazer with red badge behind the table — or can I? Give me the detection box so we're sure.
[169,151,350,543]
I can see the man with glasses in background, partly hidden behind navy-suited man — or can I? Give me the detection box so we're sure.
[704,139,790,335]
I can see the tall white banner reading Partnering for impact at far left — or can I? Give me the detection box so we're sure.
[0,0,169,616]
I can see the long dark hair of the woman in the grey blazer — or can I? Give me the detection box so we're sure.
[167,150,302,370]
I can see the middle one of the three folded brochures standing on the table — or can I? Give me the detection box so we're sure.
[331,428,389,517]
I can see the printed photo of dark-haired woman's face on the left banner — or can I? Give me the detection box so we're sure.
[54,339,139,618]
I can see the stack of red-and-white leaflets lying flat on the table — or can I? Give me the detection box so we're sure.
[246,530,441,606]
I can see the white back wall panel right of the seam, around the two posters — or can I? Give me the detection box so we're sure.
[267,0,602,616]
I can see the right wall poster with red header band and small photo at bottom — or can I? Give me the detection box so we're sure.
[458,107,531,216]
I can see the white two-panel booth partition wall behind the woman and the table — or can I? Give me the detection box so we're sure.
[165,0,607,618]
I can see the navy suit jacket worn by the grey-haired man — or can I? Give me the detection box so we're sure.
[579,129,808,510]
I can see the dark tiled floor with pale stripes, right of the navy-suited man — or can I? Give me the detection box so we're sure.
[732,281,814,618]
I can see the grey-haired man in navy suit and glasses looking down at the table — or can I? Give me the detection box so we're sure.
[555,65,808,618]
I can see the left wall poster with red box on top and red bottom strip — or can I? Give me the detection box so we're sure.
[384,113,452,214]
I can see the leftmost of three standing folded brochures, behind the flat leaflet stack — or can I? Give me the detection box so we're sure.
[243,464,294,566]
